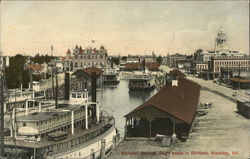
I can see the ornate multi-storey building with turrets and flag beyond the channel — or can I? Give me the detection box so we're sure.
[65,46,108,71]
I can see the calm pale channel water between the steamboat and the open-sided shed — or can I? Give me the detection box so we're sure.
[97,80,157,137]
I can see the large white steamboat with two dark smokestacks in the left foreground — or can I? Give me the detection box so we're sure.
[1,73,119,159]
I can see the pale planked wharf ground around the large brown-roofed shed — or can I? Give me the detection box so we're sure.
[107,68,250,159]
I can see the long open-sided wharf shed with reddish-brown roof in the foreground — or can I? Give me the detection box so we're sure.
[125,72,200,139]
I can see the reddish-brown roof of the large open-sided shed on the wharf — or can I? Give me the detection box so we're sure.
[125,78,200,124]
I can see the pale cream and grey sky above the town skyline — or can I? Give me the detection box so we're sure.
[0,1,249,56]
